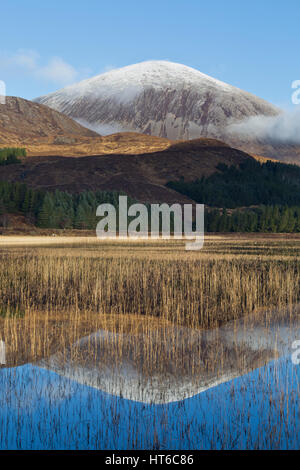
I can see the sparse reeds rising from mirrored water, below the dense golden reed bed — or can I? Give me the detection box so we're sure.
[0,310,299,450]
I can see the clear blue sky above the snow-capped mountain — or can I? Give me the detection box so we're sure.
[0,0,300,107]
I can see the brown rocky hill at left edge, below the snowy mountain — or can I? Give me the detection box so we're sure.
[0,97,99,146]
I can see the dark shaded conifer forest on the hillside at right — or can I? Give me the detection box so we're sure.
[167,159,300,208]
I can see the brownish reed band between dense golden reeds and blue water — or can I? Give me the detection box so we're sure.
[0,311,287,380]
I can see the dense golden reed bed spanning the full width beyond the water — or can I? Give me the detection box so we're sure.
[0,238,300,328]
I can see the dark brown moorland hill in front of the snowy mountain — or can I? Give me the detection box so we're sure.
[0,139,252,203]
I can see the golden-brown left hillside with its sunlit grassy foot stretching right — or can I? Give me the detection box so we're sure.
[0,97,175,156]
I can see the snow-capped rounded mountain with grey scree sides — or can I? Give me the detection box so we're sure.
[36,61,280,144]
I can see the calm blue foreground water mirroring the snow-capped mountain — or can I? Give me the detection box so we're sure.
[0,310,300,450]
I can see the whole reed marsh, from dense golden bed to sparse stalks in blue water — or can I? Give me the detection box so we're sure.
[0,237,300,449]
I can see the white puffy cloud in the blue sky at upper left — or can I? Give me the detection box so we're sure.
[0,50,81,86]
